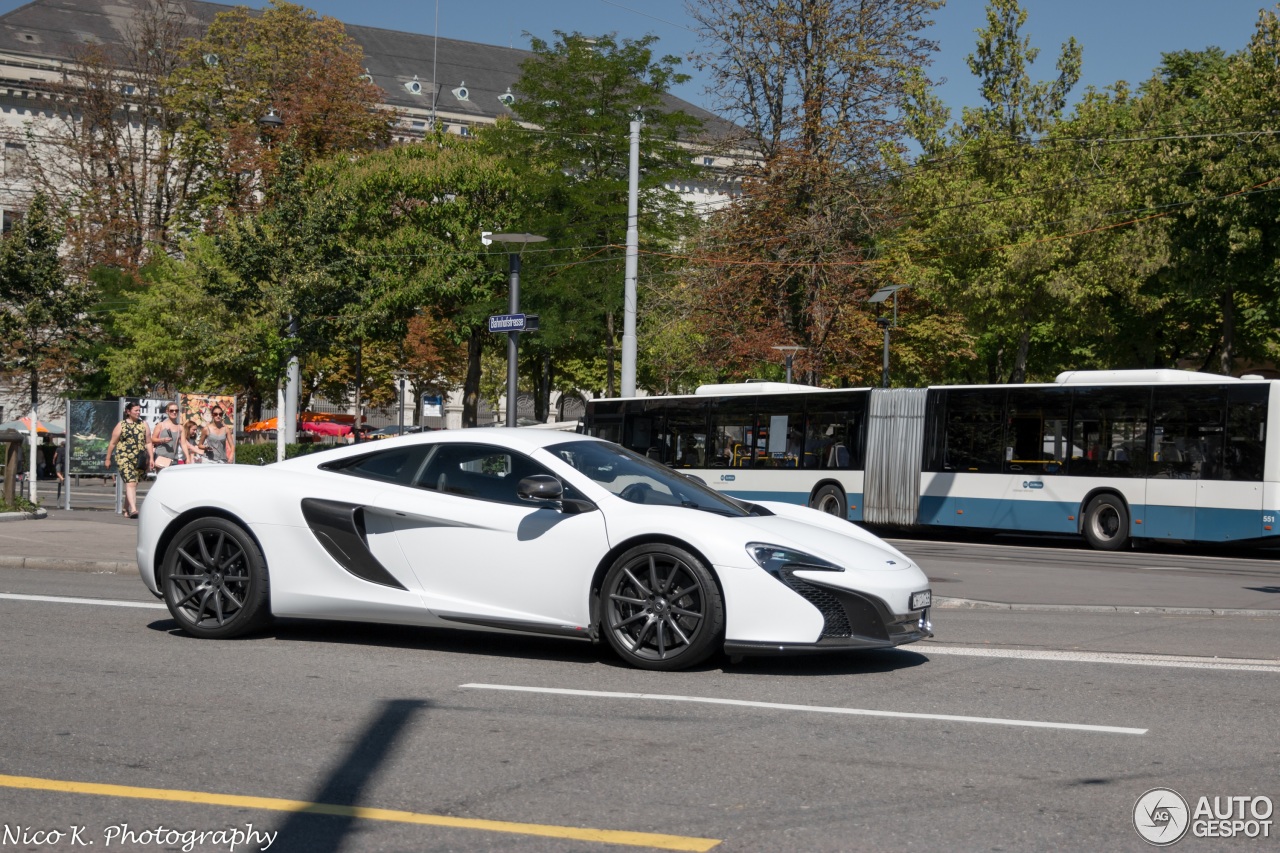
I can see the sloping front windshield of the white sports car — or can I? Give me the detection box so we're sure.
[547,441,750,517]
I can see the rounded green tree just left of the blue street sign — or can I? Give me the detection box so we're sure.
[288,142,527,427]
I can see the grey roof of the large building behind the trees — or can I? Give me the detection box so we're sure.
[0,0,732,136]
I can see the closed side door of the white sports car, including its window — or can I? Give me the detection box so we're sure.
[379,442,609,635]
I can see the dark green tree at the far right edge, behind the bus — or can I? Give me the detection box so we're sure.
[1146,23,1280,375]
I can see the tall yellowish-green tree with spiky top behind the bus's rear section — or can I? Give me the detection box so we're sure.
[902,0,1105,383]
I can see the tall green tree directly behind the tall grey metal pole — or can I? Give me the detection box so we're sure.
[480,31,701,402]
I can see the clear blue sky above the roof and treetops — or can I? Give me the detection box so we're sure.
[0,0,1266,118]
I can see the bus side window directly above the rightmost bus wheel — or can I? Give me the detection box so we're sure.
[1068,387,1151,476]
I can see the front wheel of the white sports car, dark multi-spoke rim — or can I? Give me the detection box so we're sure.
[600,543,724,670]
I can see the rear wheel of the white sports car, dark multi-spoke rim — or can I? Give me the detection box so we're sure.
[160,517,271,639]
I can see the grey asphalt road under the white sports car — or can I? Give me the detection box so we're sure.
[0,555,1280,853]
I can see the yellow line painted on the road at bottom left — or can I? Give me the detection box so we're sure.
[0,775,721,853]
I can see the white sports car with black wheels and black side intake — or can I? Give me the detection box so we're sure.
[138,429,932,670]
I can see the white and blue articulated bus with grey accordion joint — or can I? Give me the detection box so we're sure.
[584,370,1280,549]
